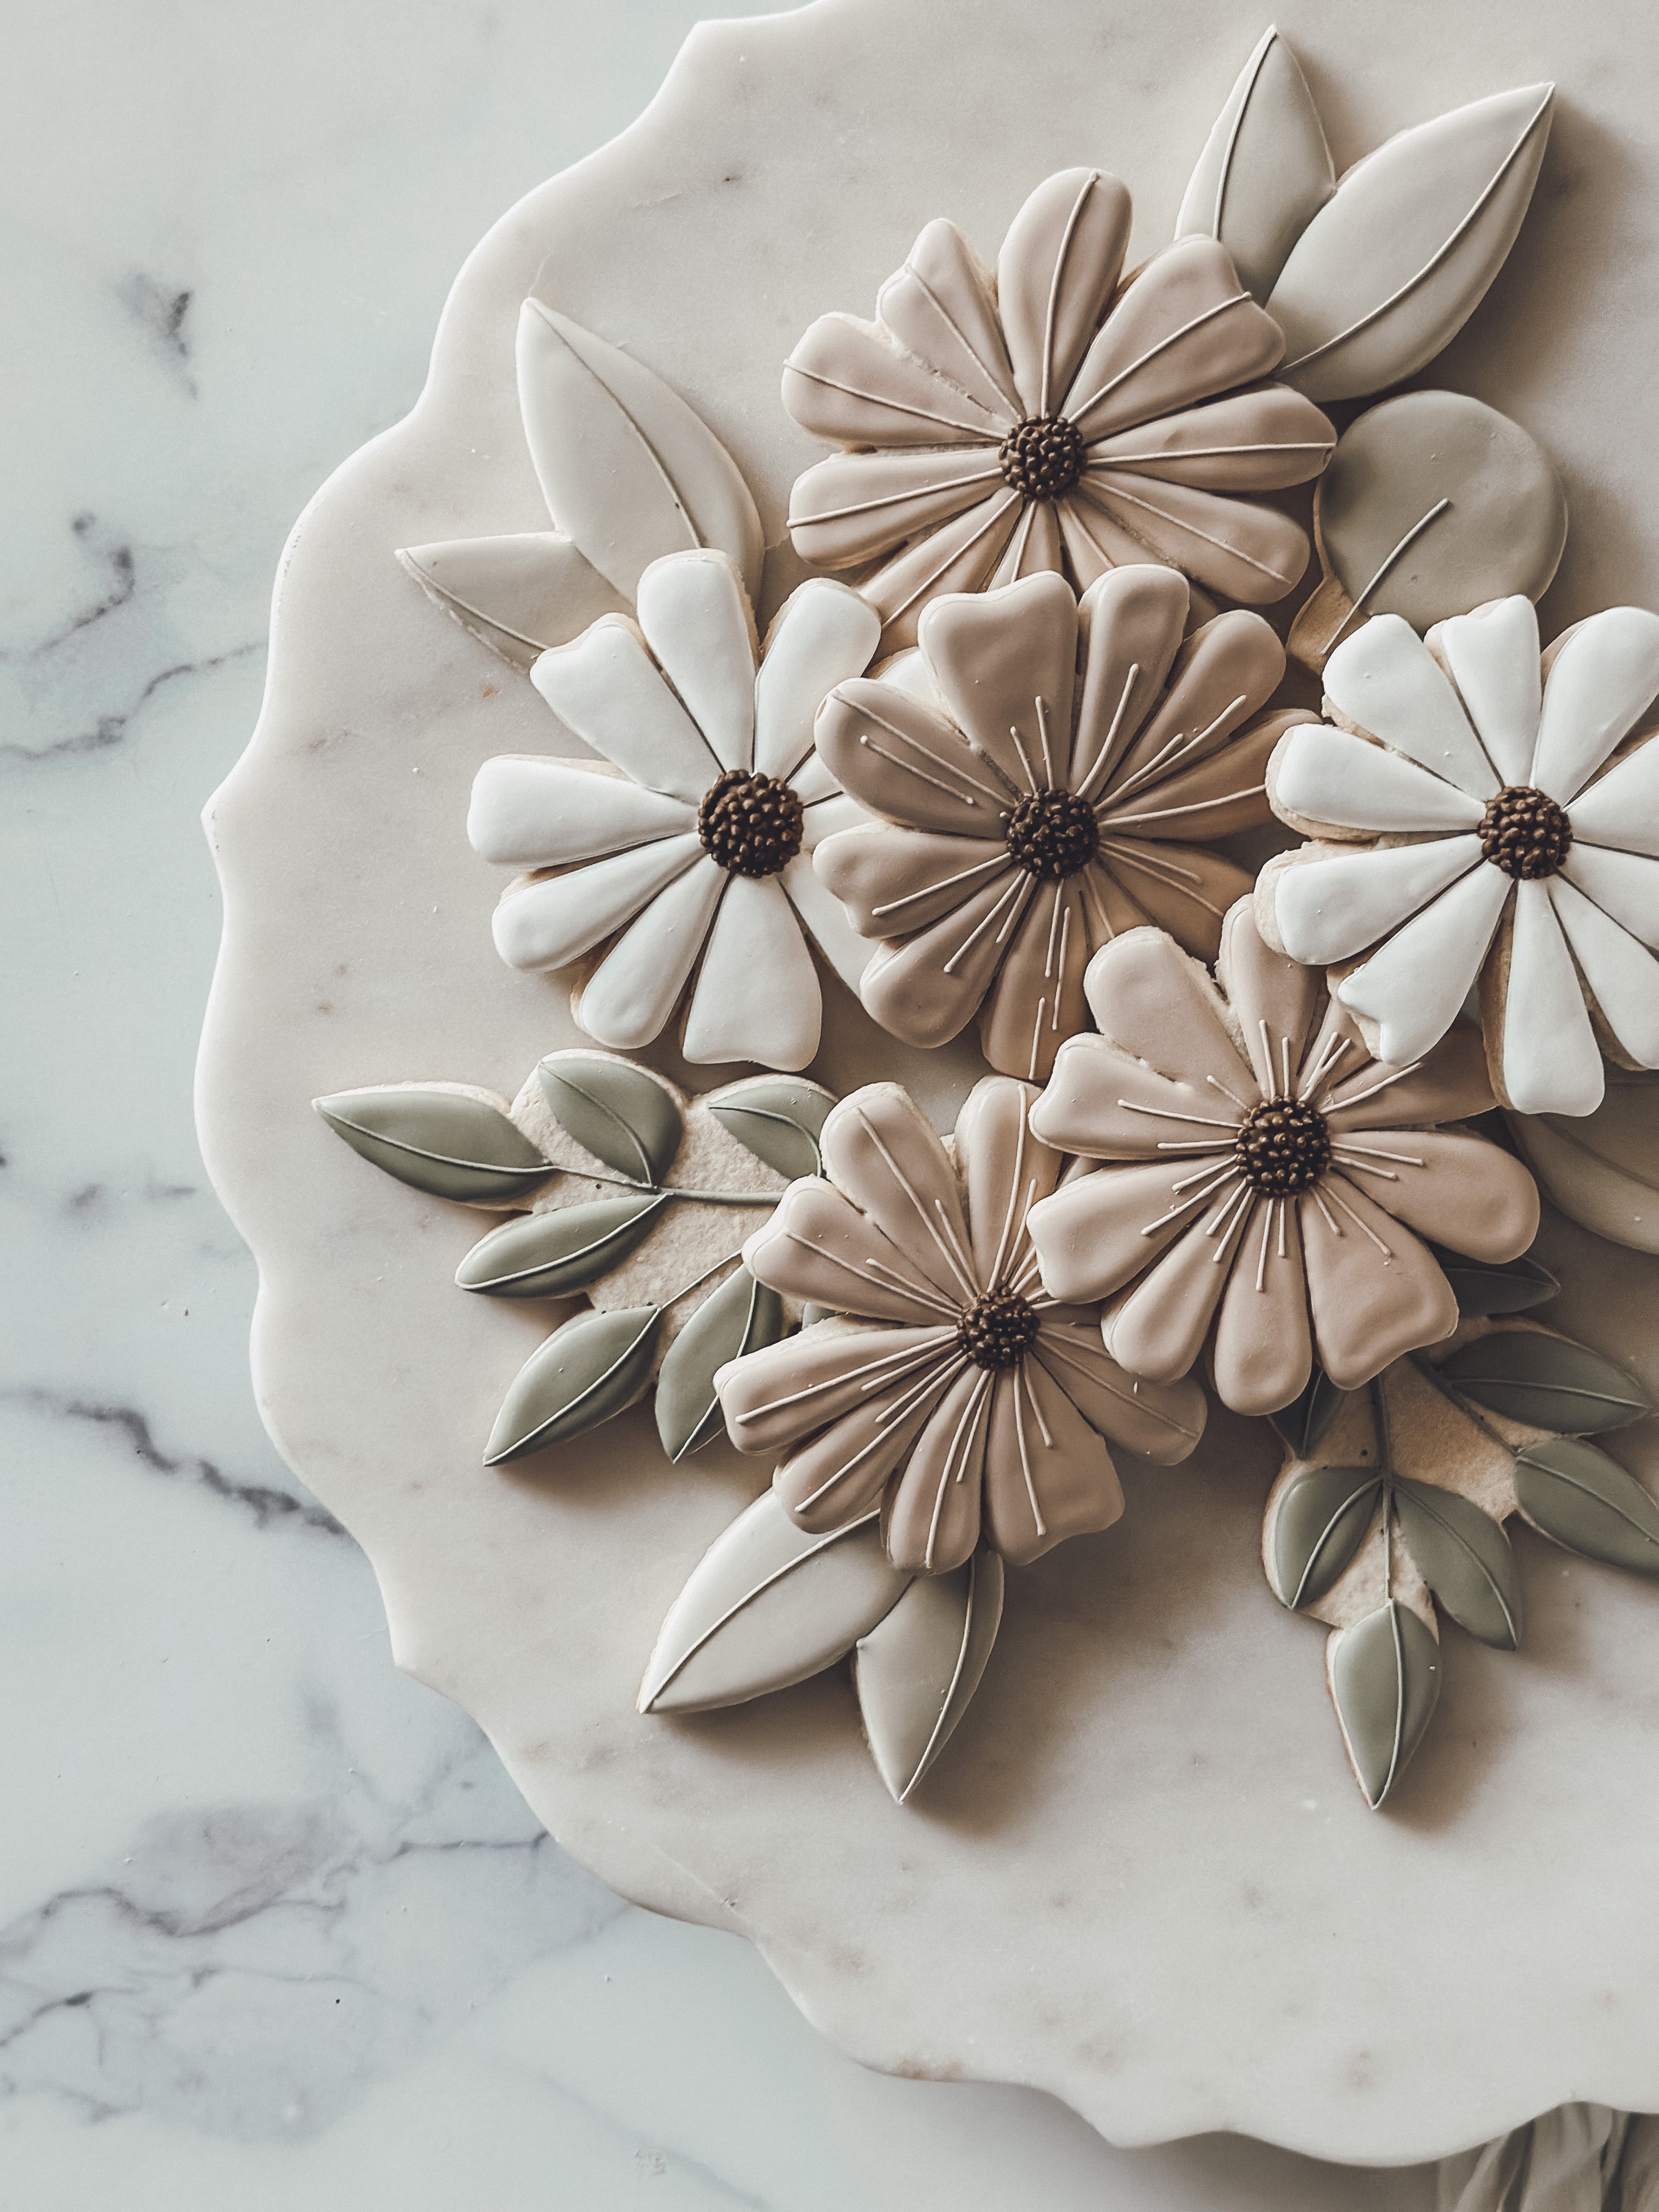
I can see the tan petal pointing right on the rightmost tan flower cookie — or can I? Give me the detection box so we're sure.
[1334,1128,1537,1261]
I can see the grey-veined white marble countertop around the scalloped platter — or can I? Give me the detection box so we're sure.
[0,0,1434,2212]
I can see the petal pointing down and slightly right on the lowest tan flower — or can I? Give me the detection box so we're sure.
[984,1358,1124,1566]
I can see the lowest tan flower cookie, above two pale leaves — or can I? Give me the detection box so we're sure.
[714,1075,1203,1575]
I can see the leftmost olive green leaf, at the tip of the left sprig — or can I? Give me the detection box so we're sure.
[312,1086,557,1205]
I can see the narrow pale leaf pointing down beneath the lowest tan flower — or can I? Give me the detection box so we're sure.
[851,1550,1002,1805]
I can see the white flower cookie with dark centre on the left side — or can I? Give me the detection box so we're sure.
[467,553,878,1068]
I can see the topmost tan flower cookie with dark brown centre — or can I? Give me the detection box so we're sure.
[783,168,1336,652]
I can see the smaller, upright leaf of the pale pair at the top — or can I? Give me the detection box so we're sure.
[1175,31,1336,301]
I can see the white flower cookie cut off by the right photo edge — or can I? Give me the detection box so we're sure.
[1256,597,1659,1115]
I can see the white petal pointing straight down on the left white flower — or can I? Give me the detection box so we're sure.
[681,876,823,1068]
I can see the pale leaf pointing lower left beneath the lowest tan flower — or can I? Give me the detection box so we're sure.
[639,1491,924,1712]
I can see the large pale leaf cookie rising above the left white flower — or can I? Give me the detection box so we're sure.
[517,298,765,604]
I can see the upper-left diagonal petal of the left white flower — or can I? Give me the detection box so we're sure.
[531,615,719,805]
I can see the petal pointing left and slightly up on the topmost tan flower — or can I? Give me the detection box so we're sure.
[783,314,1007,444]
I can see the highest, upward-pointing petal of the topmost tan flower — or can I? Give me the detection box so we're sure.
[997,168,1130,416]
